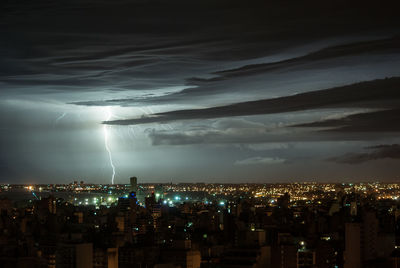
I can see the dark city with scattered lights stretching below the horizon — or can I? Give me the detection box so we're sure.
[0,177,400,268]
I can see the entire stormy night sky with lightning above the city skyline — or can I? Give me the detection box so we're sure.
[0,0,400,183]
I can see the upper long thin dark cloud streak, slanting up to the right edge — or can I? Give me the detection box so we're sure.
[73,36,400,106]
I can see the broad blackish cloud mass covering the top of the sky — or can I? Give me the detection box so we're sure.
[0,1,397,98]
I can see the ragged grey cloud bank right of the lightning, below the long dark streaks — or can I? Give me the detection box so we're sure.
[147,117,397,147]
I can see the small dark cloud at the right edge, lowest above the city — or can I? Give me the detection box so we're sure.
[328,144,400,164]
